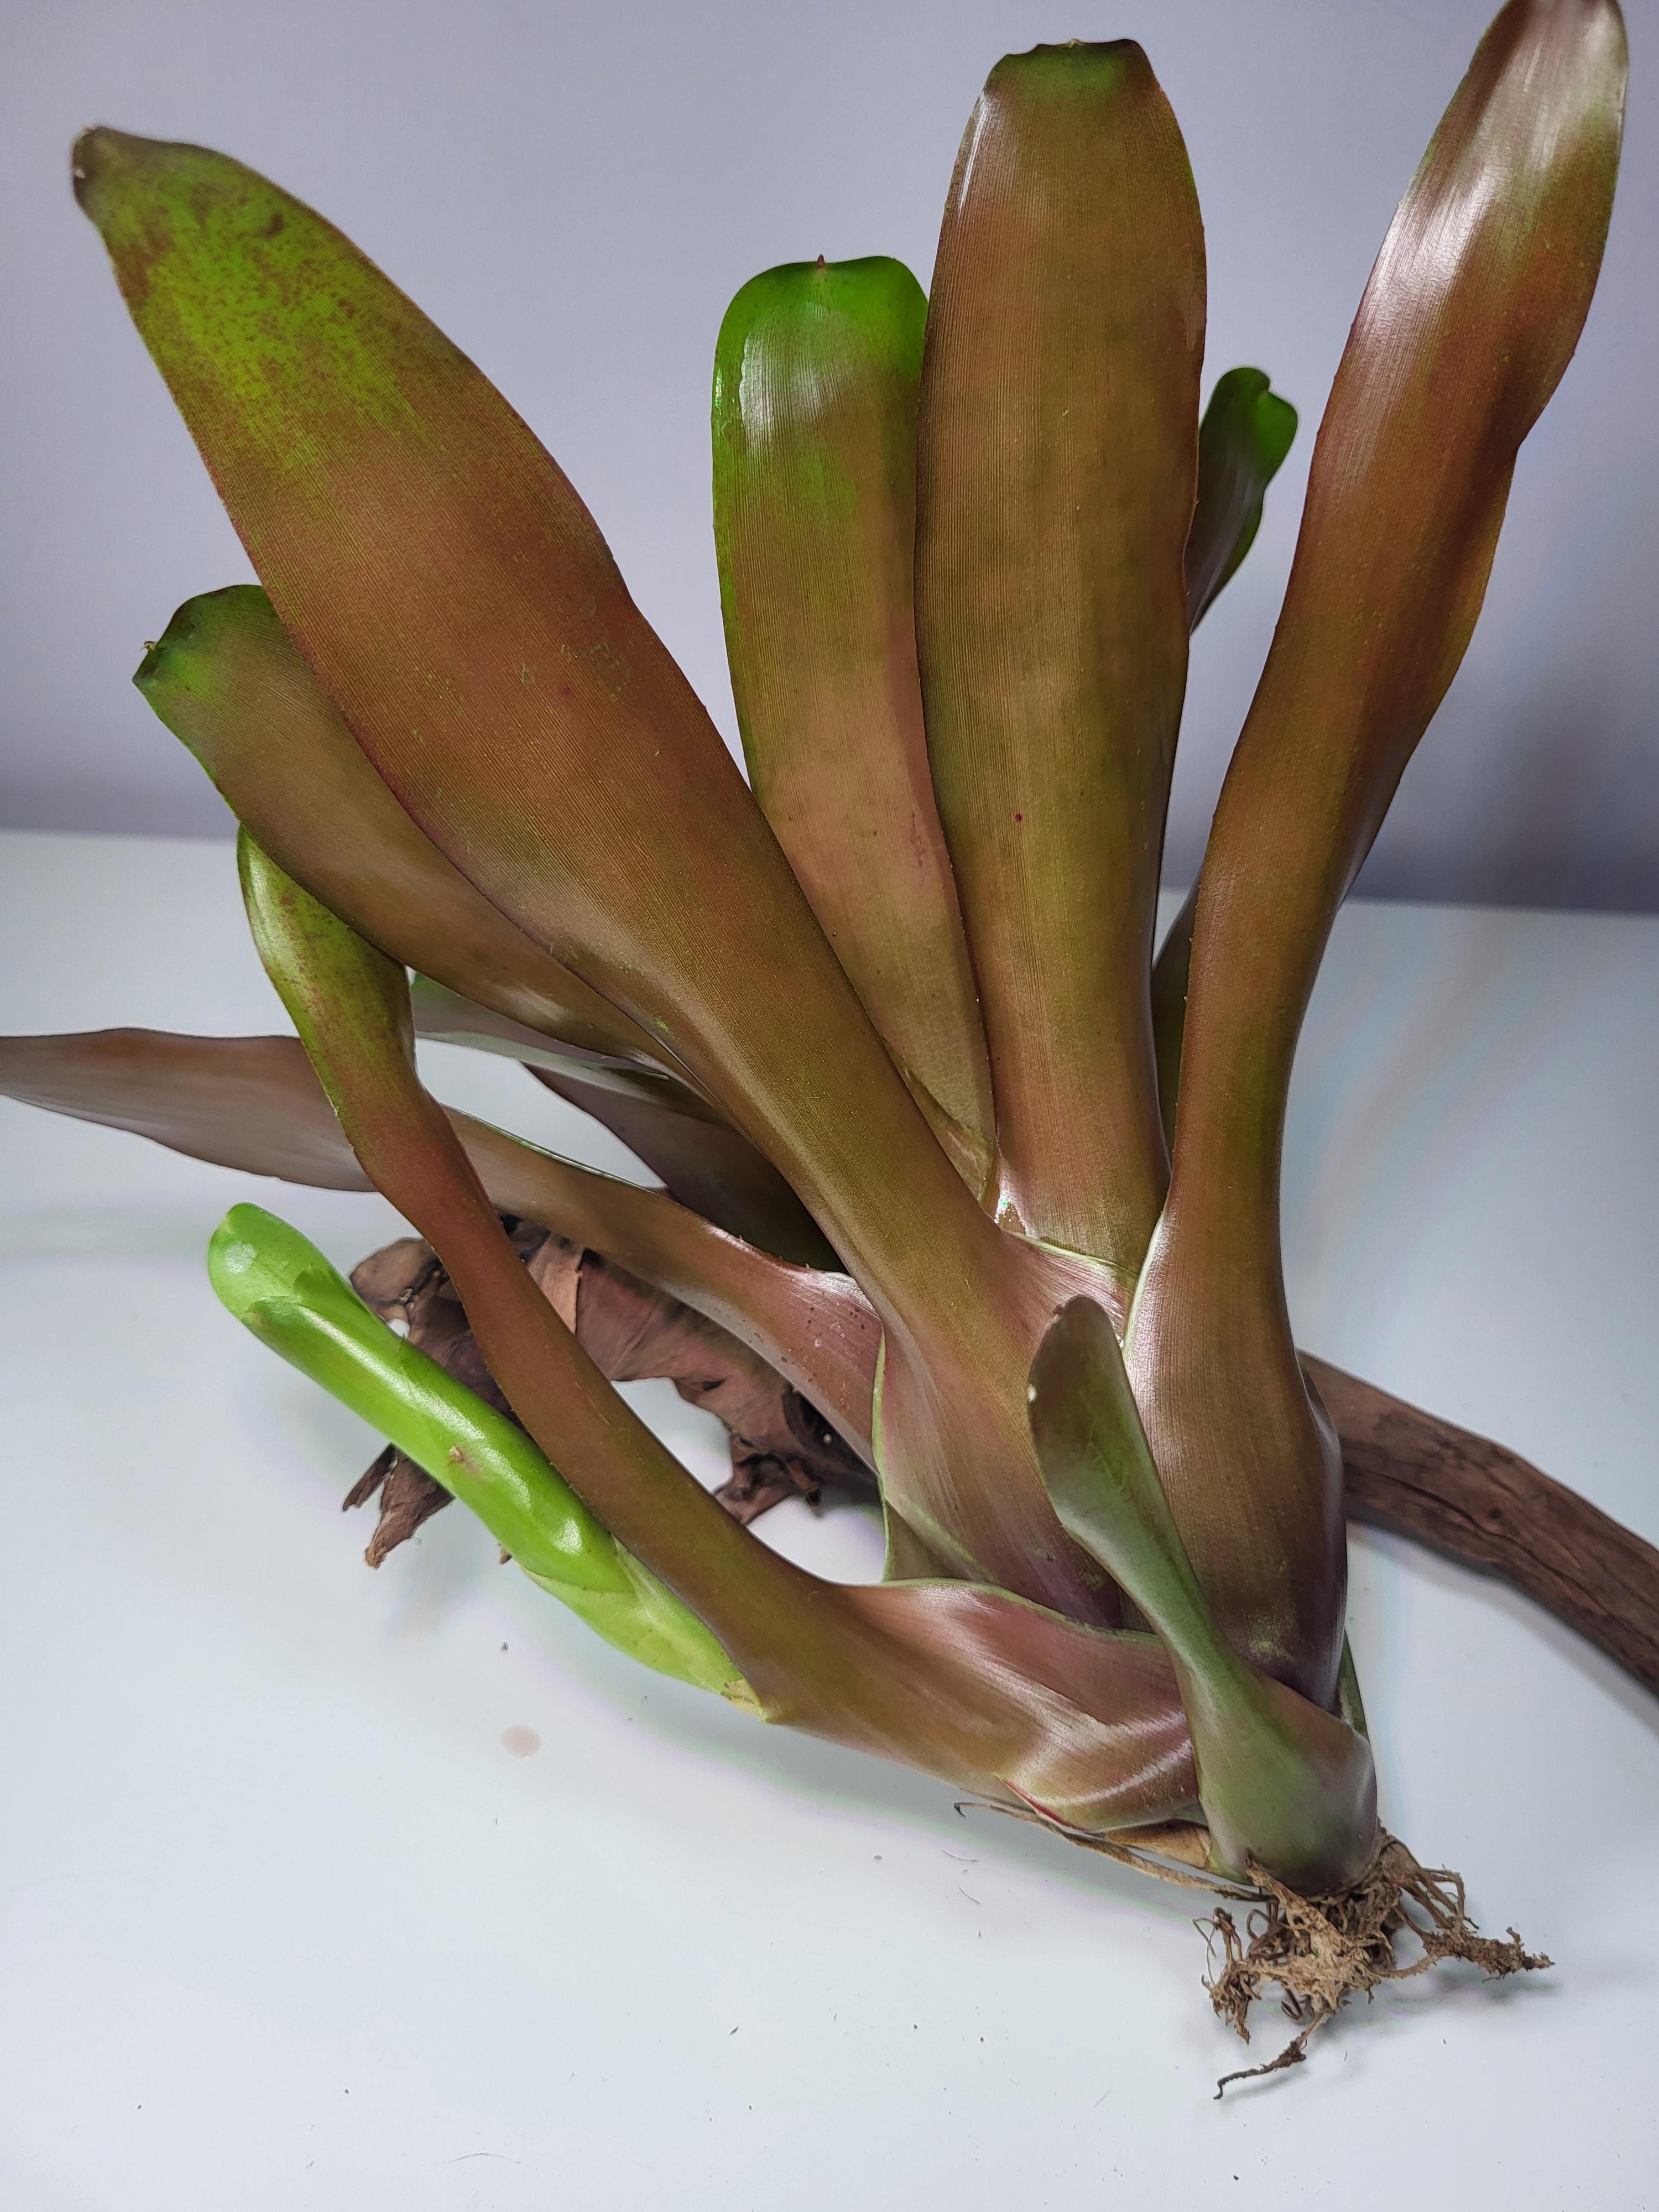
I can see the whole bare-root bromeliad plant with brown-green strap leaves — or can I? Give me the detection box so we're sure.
[4,0,1624,2064]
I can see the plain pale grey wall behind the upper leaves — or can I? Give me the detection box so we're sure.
[0,0,1659,907]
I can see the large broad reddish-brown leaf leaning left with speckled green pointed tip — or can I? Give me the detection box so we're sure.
[75,131,1119,1621]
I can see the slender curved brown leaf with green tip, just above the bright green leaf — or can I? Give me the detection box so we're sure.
[241,832,1192,1827]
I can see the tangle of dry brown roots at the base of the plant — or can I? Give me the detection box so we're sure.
[1197,1834,1551,2097]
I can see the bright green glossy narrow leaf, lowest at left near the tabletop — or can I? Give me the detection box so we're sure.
[208,1206,754,1708]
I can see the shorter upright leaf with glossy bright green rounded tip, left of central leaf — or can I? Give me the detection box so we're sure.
[714,259,993,1181]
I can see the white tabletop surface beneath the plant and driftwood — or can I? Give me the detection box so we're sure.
[0,834,1659,2212]
